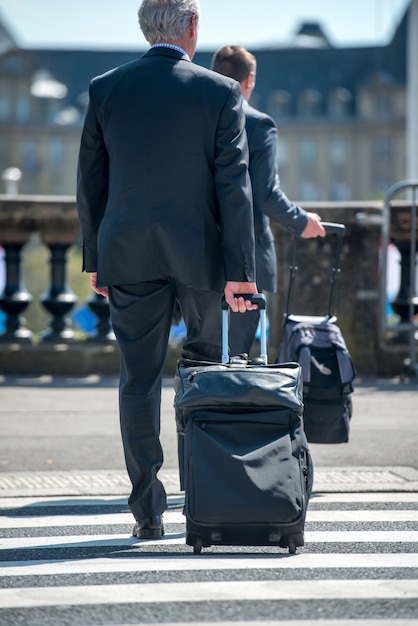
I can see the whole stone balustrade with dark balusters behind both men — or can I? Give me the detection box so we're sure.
[0,195,414,376]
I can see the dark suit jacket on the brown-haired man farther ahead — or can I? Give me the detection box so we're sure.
[244,103,308,291]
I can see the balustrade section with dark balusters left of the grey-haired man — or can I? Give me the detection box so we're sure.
[0,196,114,344]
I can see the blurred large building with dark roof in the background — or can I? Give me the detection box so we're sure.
[0,4,408,202]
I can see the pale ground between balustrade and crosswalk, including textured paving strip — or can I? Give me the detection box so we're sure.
[0,376,418,498]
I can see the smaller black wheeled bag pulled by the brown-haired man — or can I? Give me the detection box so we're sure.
[277,222,355,443]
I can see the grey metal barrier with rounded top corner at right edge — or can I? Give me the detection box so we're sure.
[379,180,418,378]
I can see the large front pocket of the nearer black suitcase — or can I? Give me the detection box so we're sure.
[185,409,306,524]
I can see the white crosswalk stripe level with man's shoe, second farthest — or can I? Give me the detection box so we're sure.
[0,510,418,530]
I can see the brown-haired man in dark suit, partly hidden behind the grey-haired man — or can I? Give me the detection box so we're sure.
[212,46,325,354]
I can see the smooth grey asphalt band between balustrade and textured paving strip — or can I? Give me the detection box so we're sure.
[0,376,418,472]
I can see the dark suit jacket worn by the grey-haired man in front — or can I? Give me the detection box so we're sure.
[77,47,255,292]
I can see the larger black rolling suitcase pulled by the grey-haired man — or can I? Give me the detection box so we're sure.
[174,294,313,554]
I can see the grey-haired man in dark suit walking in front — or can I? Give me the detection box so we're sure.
[77,0,257,539]
